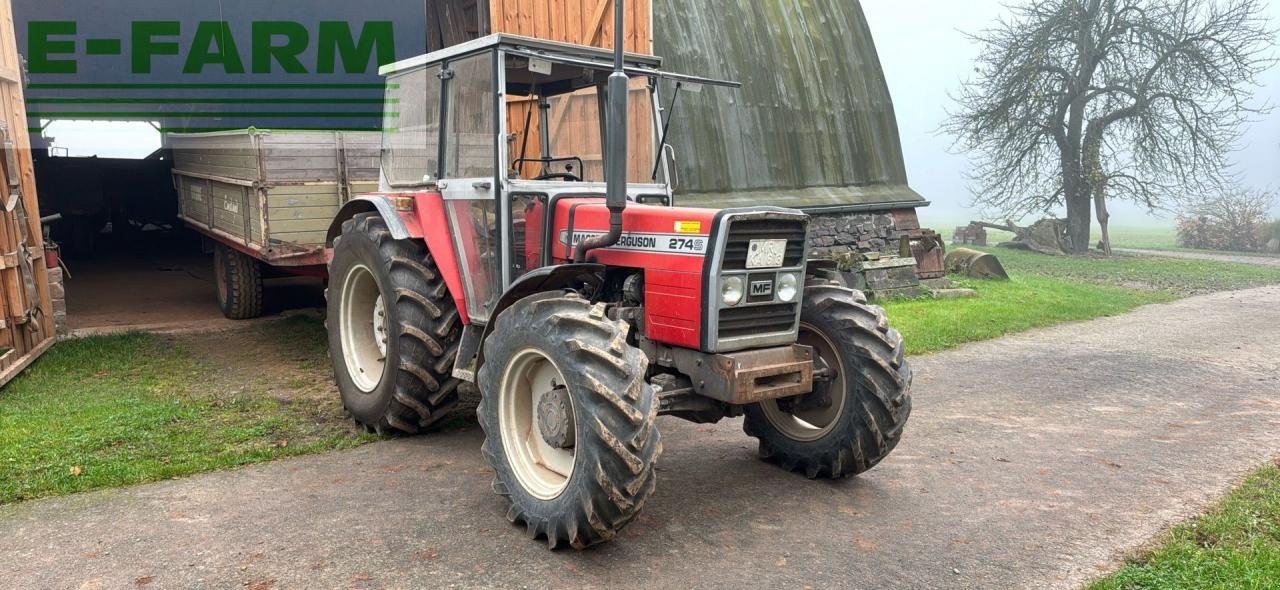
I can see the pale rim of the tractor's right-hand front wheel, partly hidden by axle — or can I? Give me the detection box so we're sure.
[760,323,847,443]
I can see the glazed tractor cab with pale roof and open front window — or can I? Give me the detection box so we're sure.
[381,35,737,323]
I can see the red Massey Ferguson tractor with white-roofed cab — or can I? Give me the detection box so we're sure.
[328,3,911,549]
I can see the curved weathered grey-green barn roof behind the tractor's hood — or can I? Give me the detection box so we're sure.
[653,0,922,206]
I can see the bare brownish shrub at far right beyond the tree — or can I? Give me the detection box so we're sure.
[1178,191,1280,252]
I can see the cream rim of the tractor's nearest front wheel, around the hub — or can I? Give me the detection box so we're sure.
[498,348,575,500]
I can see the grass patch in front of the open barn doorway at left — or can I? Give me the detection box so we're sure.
[0,324,370,503]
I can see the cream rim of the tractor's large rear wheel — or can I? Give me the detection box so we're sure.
[338,265,388,393]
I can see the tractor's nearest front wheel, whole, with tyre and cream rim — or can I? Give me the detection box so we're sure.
[476,293,662,549]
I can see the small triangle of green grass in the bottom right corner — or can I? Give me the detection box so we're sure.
[1088,466,1280,590]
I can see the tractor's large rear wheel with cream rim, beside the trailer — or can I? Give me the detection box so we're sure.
[325,212,462,434]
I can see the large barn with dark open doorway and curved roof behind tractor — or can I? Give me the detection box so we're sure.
[0,0,941,376]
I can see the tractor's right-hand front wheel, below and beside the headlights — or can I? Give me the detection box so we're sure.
[744,283,911,479]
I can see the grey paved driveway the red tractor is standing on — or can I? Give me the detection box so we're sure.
[0,287,1280,589]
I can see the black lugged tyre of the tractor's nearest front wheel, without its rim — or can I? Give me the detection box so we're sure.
[476,293,662,549]
